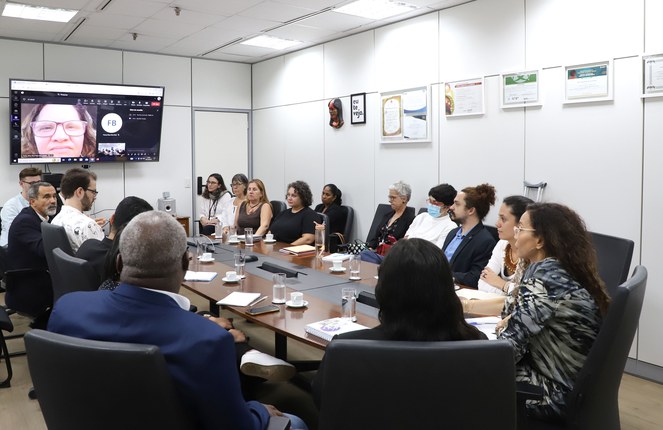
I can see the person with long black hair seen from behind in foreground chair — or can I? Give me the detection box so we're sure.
[313,239,486,405]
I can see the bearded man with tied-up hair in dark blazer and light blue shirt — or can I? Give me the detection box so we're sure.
[442,184,495,288]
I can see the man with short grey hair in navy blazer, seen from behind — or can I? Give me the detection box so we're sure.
[48,211,305,429]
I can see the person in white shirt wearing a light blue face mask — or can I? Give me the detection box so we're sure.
[405,184,458,248]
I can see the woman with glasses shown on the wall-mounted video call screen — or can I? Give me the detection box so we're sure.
[21,104,97,158]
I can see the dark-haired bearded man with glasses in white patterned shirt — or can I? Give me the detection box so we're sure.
[51,167,104,252]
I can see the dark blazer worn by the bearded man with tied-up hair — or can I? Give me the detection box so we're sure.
[442,222,495,288]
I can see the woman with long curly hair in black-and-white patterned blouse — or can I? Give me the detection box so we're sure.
[500,203,610,420]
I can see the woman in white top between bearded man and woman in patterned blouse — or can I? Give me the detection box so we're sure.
[478,196,534,295]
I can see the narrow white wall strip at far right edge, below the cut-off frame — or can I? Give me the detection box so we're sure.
[640,98,663,366]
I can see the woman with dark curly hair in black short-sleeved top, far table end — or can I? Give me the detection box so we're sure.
[270,181,320,245]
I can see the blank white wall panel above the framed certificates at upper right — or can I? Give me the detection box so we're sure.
[528,0,644,67]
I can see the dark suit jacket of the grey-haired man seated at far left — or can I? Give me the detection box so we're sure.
[7,206,48,270]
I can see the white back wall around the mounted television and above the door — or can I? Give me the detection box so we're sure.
[0,39,251,232]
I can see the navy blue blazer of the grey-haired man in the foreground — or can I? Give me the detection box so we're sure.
[48,284,269,430]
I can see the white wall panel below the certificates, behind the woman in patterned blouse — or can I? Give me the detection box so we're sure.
[525,57,642,247]
